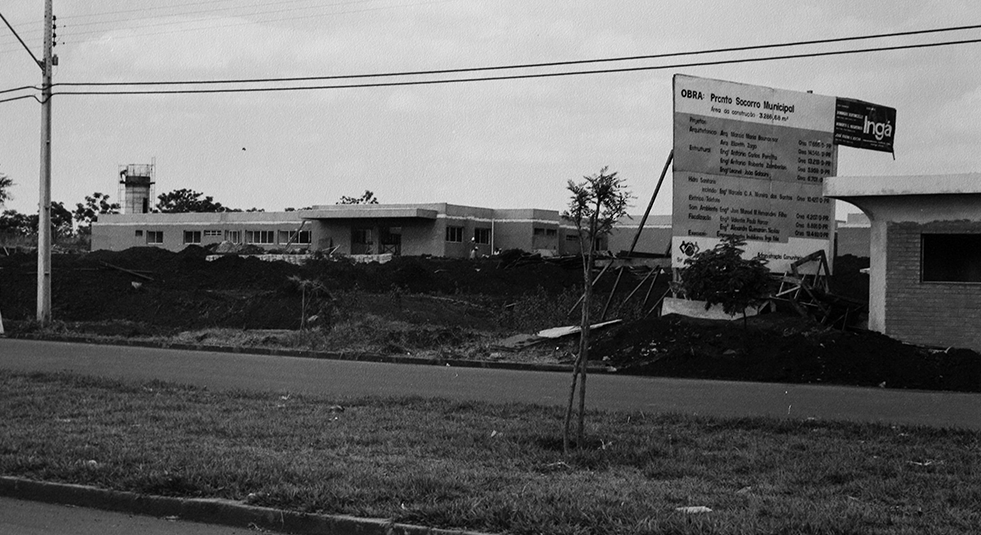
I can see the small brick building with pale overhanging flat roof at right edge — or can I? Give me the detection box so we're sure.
[825,174,981,350]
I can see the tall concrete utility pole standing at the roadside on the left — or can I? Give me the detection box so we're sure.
[37,0,54,325]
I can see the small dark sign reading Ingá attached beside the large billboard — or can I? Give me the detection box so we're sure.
[835,97,896,152]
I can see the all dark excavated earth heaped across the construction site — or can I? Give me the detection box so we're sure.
[0,246,981,392]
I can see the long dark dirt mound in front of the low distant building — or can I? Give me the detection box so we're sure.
[0,246,579,330]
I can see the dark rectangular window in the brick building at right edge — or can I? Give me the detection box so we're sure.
[920,234,981,282]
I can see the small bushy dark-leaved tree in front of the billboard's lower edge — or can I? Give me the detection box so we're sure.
[681,235,771,325]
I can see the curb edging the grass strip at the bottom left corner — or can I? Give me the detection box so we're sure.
[0,476,484,535]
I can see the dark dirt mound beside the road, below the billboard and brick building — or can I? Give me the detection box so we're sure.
[593,314,981,392]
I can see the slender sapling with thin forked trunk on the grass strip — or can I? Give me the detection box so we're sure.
[562,167,630,454]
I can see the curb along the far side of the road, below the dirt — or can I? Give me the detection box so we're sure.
[5,333,616,374]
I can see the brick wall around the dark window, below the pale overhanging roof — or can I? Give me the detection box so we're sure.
[885,221,981,351]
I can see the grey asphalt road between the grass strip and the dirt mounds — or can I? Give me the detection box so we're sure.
[0,339,981,430]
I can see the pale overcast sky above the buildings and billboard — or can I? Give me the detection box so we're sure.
[0,0,981,218]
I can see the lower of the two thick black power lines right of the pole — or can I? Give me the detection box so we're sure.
[46,39,981,95]
